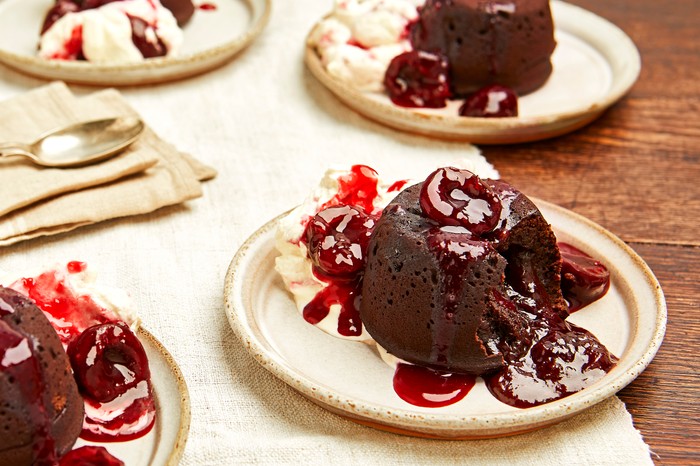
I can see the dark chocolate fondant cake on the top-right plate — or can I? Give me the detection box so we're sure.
[410,0,556,96]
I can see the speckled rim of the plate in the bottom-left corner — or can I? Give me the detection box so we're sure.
[137,326,192,466]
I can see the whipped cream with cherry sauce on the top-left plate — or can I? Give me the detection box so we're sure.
[39,0,183,64]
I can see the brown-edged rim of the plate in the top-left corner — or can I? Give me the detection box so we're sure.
[0,0,272,86]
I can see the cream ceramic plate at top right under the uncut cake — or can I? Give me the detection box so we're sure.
[305,0,641,144]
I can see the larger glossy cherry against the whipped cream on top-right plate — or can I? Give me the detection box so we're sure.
[384,50,451,108]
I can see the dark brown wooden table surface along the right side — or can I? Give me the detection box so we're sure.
[482,0,700,464]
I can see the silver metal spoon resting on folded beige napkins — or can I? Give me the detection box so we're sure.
[0,117,144,168]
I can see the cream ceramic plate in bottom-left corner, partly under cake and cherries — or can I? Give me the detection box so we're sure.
[76,328,190,466]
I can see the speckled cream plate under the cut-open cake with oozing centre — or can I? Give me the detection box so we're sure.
[224,200,666,439]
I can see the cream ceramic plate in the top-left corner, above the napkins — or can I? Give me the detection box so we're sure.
[0,0,271,86]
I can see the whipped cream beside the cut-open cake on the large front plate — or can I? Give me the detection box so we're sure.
[275,168,404,342]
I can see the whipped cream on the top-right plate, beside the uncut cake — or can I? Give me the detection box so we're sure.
[309,0,425,91]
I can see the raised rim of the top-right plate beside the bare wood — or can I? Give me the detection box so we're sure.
[304,0,641,144]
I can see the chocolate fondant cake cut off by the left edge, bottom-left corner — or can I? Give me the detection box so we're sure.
[0,287,83,465]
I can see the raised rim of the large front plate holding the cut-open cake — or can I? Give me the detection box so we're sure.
[224,198,667,440]
